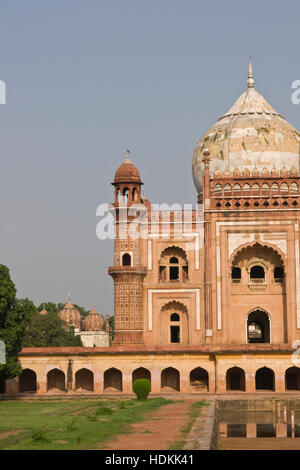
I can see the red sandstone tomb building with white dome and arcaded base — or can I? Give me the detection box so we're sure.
[6,64,300,394]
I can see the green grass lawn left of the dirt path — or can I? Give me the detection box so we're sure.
[0,398,172,450]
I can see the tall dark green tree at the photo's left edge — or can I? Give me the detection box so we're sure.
[0,264,36,379]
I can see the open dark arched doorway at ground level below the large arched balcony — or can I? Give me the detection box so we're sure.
[247,309,270,343]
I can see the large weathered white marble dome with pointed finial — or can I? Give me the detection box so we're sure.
[193,60,300,201]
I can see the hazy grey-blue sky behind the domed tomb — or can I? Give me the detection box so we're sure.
[0,0,300,314]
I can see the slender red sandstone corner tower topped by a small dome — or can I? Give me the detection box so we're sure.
[108,151,147,344]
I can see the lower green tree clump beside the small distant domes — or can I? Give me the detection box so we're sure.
[23,310,82,348]
